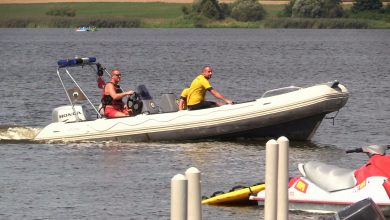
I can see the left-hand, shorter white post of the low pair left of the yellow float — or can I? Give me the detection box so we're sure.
[171,174,187,220]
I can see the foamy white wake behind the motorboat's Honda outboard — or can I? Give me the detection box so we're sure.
[0,125,41,144]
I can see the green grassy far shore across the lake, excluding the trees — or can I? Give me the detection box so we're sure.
[0,3,390,28]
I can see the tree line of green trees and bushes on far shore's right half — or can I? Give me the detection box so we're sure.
[182,0,390,26]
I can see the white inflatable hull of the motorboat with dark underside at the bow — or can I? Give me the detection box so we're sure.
[35,84,348,141]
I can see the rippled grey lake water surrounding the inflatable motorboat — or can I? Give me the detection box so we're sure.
[0,29,390,220]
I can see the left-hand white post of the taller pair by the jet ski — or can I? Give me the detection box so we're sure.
[264,139,278,220]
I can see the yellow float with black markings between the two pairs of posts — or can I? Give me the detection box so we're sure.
[202,184,265,205]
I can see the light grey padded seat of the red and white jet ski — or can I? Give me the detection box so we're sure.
[303,161,356,192]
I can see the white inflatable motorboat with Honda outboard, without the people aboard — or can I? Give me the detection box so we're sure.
[35,57,348,142]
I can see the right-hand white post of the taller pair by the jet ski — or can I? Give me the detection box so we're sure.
[277,136,290,220]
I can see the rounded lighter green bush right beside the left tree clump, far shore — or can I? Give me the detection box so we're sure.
[231,0,266,22]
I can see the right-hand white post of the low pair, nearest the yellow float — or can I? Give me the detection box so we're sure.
[185,167,202,220]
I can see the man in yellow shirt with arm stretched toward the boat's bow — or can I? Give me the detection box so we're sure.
[187,66,233,110]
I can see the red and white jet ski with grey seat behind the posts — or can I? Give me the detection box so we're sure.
[250,145,390,216]
